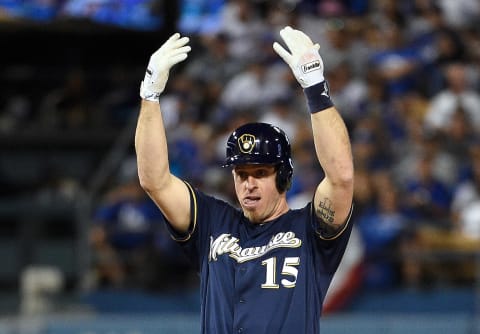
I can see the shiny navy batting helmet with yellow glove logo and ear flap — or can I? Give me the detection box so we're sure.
[223,123,293,192]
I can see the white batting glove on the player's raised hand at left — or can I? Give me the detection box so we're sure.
[140,33,191,102]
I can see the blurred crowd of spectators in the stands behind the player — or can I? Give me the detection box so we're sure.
[0,0,480,298]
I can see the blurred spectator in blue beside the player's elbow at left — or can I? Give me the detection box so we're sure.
[90,163,161,288]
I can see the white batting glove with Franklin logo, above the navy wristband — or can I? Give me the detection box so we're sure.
[273,26,325,88]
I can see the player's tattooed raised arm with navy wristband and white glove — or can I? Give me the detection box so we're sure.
[273,27,353,231]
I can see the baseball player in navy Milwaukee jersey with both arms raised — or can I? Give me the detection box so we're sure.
[135,26,353,334]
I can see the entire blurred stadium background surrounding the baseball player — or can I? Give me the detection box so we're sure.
[0,0,480,334]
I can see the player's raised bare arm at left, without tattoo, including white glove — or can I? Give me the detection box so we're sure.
[135,33,190,233]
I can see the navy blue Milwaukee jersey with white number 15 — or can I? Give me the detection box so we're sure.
[165,186,351,334]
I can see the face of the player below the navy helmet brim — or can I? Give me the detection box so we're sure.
[232,165,288,223]
